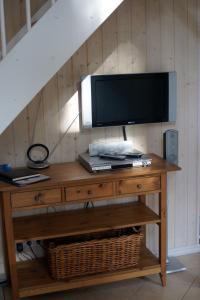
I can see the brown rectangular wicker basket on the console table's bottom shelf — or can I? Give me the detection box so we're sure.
[46,228,143,280]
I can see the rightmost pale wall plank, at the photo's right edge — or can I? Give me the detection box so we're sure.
[186,0,198,245]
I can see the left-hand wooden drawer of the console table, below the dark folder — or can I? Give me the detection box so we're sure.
[11,189,61,208]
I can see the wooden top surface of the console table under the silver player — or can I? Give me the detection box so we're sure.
[0,154,181,192]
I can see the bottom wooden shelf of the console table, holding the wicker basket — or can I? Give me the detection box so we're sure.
[17,248,161,298]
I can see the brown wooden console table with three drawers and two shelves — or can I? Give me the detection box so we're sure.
[0,154,180,300]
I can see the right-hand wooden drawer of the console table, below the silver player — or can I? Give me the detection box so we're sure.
[116,176,160,195]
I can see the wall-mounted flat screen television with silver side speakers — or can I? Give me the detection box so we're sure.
[81,72,176,128]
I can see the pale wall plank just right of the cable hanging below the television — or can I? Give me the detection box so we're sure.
[130,0,147,153]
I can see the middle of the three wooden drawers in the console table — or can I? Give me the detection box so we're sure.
[65,182,114,201]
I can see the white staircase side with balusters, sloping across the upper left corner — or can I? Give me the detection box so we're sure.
[0,0,123,134]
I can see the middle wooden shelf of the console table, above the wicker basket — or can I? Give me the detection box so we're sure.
[14,202,160,243]
